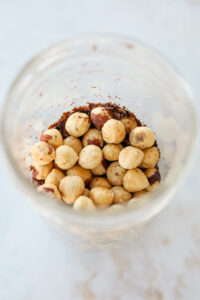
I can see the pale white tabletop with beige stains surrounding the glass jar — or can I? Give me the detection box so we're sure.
[0,0,200,300]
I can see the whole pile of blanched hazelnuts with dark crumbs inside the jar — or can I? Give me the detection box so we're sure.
[31,103,160,211]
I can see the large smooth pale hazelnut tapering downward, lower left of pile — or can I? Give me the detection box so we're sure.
[59,176,85,204]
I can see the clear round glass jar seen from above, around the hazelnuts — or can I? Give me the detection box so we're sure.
[1,35,196,248]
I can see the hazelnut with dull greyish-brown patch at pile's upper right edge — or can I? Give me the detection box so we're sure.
[129,126,156,149]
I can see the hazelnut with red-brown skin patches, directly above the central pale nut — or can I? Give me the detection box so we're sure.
[83,128,104,148]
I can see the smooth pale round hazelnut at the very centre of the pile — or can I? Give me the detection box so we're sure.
[78,145,103,169]
